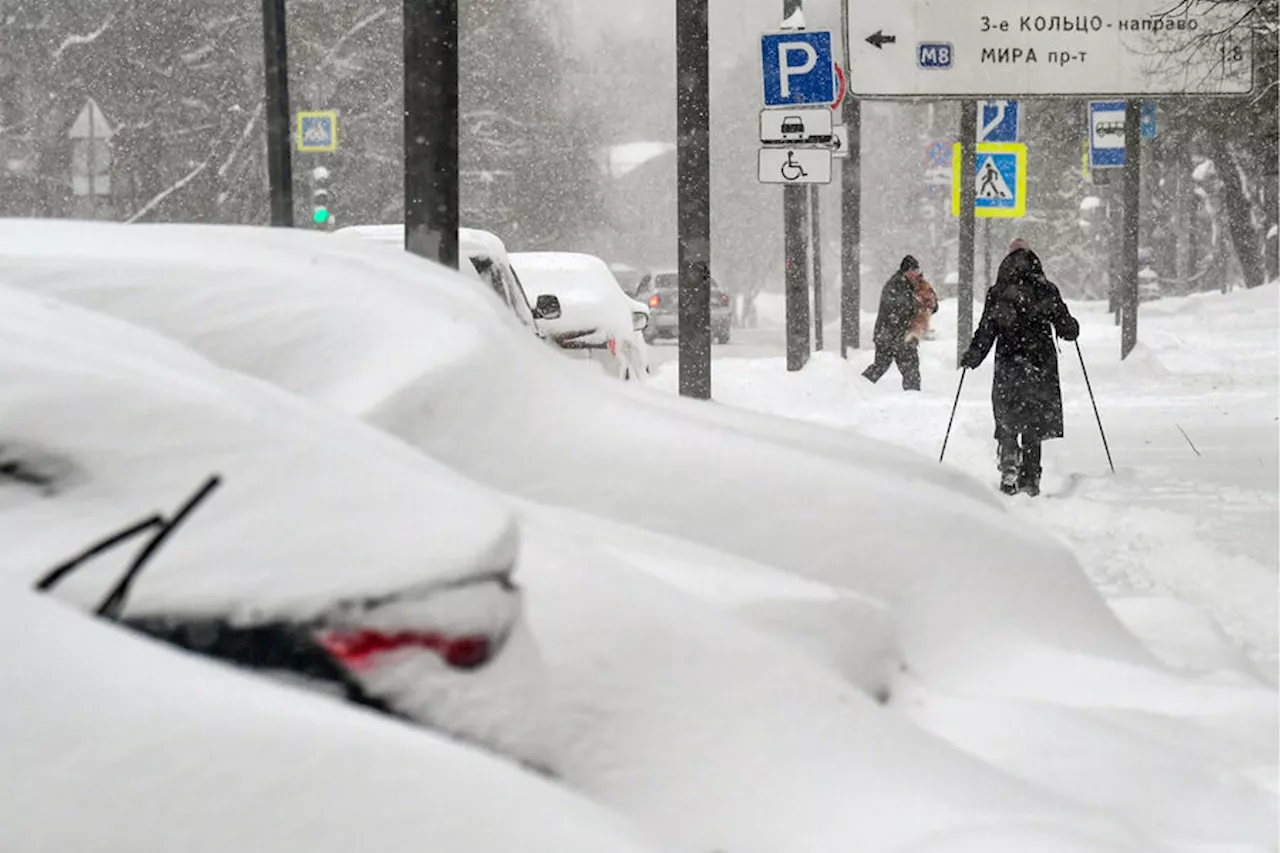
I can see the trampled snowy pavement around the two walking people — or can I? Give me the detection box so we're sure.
[653,284,1280,685]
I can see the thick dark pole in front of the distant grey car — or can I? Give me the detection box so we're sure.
[676,0,712,400]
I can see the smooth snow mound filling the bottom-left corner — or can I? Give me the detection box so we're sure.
[0,579,659,853]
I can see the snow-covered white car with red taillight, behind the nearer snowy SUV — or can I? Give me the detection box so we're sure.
[511,252,649,379]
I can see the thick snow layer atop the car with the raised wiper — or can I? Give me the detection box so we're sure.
[0,279,516,615]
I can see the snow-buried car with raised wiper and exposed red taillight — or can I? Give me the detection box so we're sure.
[0,280,550,767]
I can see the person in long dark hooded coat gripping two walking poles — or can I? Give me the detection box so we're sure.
[960,241,1080,496]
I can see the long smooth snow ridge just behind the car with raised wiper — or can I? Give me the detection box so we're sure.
[0,222,1155,674]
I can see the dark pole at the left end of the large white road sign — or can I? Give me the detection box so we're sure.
[840,0,863,359]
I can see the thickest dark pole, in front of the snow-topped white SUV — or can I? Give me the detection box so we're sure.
[404,0,458,269]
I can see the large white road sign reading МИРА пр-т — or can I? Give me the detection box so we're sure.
[846,0,1253,100]
